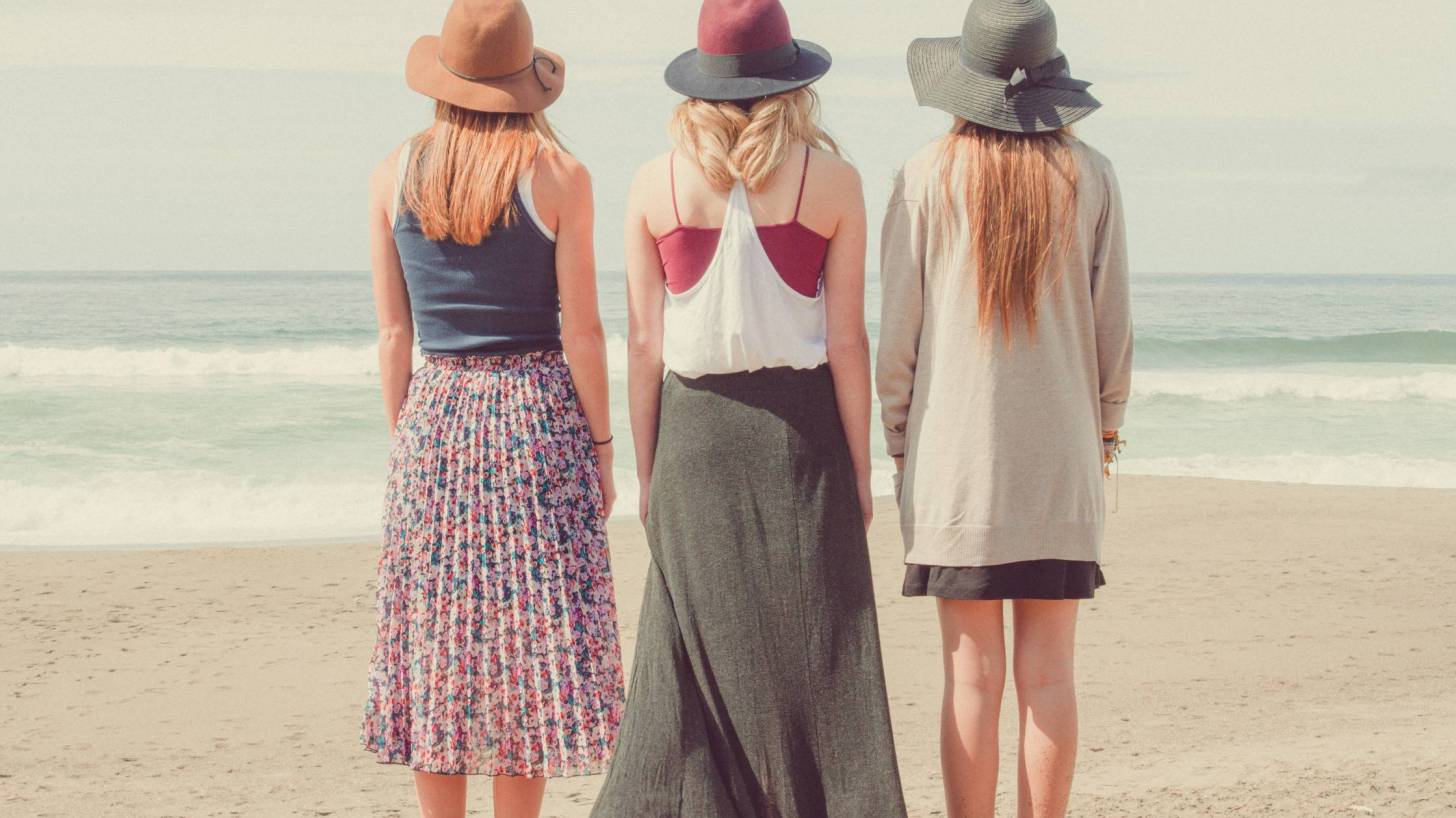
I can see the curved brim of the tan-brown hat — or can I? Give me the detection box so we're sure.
[405,35,566,114]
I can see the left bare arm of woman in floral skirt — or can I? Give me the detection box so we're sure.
[368,150,415,434]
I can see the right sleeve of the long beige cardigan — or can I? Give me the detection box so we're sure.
[1092,157,1133,431]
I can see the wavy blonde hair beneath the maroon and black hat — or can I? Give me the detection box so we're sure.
[670,87,839,191]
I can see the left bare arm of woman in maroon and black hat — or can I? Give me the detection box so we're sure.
[626,165,665,523]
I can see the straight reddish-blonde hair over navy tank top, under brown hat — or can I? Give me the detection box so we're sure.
[403,100,563,245]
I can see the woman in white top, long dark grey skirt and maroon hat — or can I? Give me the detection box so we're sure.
[593,0,904,818]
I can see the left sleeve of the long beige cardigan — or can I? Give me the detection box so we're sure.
[875,170,925,457]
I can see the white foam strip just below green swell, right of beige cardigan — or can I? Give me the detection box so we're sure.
[1133,370,1456,402]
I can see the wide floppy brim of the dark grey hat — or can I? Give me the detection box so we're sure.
[906,36,1102,134]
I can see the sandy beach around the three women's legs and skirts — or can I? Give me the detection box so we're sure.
[0,477,1456,818]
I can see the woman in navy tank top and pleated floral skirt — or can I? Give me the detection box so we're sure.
[364,0,623,818]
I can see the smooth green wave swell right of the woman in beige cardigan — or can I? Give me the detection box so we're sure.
[1137,329,1456,365]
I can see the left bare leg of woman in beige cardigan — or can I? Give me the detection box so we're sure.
[938,590,1006,818]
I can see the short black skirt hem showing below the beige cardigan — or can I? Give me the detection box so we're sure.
[901,559,1107,600]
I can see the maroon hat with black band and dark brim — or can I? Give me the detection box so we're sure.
[664,0,831,102]
